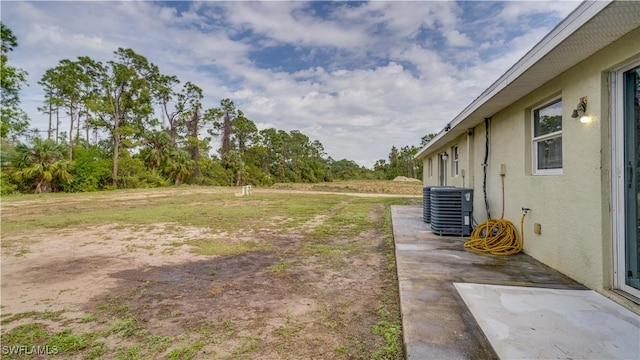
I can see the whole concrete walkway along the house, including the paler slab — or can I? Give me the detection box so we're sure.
[391,206,640,359]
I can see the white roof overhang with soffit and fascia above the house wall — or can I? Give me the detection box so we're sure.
[416,1,640,158]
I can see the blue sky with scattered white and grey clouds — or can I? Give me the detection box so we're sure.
[0,1,579,167]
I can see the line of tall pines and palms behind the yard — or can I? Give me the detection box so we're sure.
[0,23,422,194]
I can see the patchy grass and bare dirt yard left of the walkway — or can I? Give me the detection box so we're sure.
[1,182,422,359]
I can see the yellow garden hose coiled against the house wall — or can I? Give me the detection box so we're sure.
[464,209,529,255]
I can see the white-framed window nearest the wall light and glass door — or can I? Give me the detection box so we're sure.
[533,99,562,175]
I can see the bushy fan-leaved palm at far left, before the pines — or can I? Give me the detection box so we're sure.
[12,138,73,193]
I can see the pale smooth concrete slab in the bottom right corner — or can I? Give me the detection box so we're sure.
[454,283,640,359]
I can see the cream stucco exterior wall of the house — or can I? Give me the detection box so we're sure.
[423,29,640,290]
